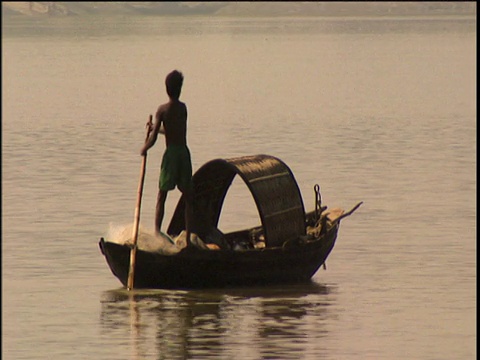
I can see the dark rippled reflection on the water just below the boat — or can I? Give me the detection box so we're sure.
[100,282,335,359]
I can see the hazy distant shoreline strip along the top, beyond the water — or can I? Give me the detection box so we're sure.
[2,1,477,20]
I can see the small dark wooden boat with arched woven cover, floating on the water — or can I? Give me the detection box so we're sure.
[99,155,361,289]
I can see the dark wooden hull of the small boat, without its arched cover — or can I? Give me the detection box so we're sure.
[99,224,339,289]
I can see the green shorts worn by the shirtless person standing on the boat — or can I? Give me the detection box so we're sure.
[159,145,192,191]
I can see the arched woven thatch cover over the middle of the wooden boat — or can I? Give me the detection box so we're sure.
[168,155,305,247]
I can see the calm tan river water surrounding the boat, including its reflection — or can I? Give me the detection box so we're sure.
[2,18,477,360]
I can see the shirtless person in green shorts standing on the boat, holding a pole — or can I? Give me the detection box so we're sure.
[141,70,193,245]
